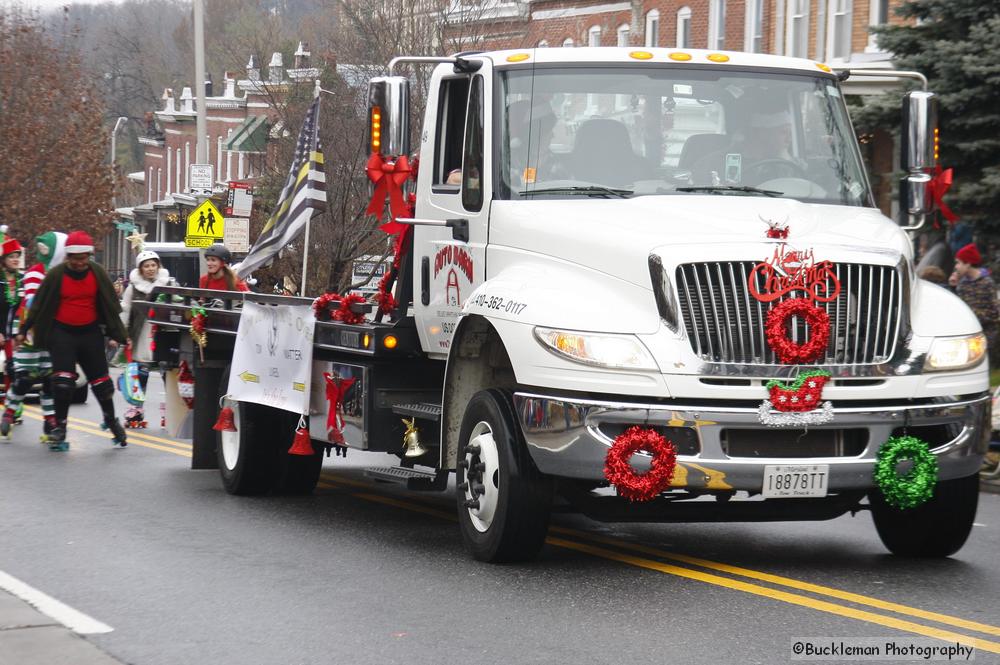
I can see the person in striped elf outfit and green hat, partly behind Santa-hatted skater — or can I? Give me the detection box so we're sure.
[0,231,66,437]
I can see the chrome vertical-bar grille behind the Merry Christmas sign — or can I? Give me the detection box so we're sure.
[677,261,905,365]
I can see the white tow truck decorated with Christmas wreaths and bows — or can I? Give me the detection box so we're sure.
[153,48,990,561]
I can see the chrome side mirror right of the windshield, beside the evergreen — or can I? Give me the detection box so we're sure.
[899,90,938,230]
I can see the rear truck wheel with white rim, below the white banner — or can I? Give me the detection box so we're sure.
[216,368,278,496]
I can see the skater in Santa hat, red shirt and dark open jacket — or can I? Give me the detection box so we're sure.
[18,231,128,450]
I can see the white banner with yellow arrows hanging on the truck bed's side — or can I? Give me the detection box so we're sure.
[228,301,316,414]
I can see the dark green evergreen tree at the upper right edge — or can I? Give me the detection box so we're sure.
[858,0,1000,235]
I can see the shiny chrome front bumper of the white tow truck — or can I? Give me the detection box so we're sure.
[514,392,990,492]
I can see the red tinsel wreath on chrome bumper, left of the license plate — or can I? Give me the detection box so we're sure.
[604,427,677,501]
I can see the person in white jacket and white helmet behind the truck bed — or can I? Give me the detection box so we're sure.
[121,250,177,427]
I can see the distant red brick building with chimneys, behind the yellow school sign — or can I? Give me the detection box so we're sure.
[115,43,319,271]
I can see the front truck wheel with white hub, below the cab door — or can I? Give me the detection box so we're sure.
[456,390,554,563]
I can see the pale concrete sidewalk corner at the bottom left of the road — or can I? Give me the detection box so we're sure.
[0,591,122,665]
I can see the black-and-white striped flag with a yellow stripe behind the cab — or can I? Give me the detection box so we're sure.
[237,96,326,278]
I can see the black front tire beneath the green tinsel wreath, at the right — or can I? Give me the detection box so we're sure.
[868,474,979,557]
